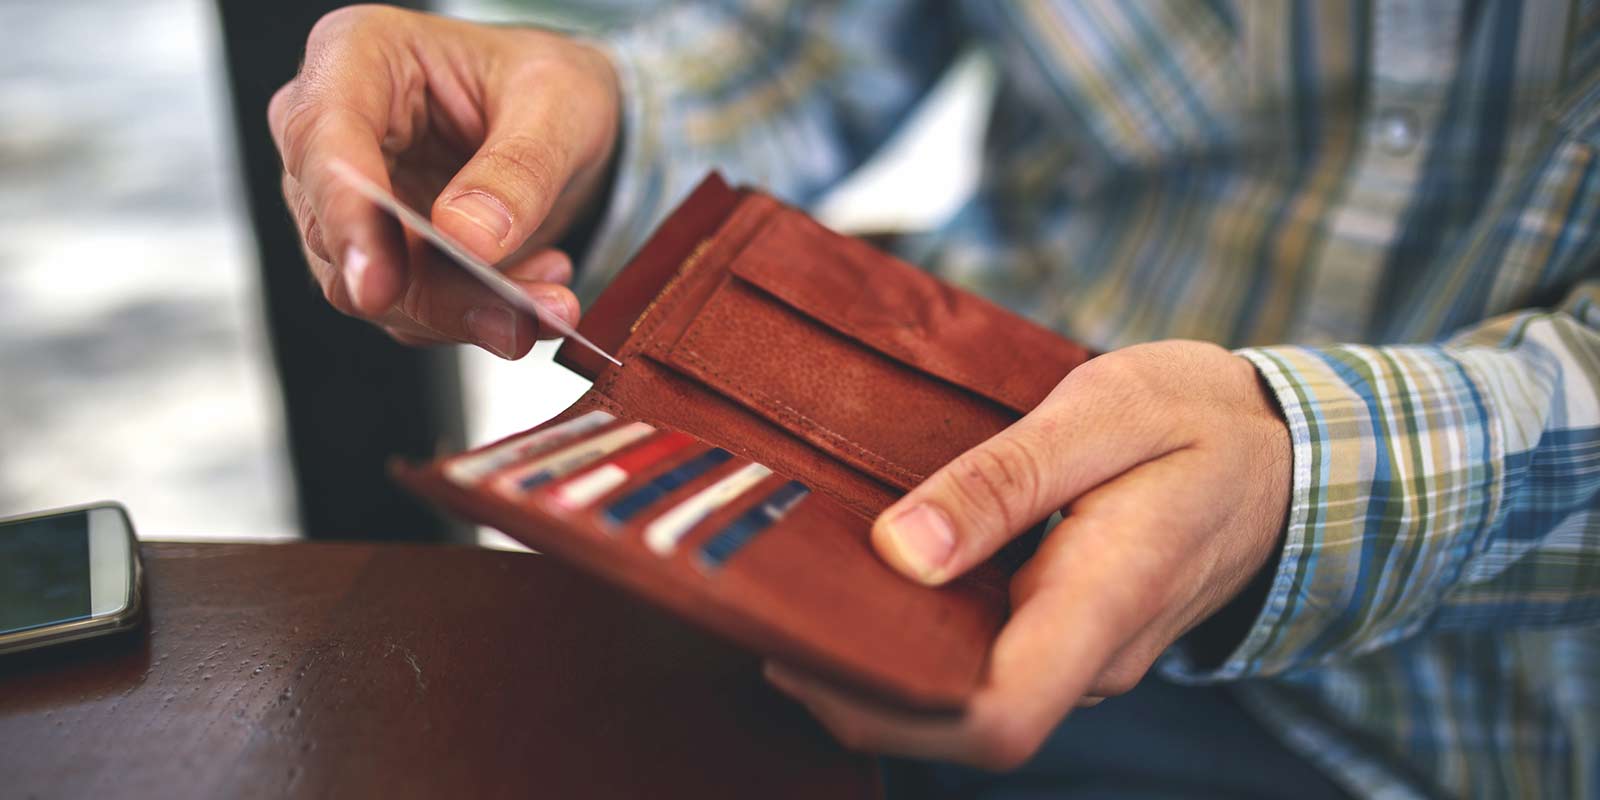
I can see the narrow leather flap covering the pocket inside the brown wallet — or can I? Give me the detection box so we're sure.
[730,208,1088,414]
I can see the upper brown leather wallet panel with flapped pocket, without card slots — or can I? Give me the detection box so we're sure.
[651,208,1082,490]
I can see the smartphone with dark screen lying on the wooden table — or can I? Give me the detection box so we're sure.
[0,502,144,653]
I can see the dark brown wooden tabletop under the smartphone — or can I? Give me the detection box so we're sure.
[0,544,877,798]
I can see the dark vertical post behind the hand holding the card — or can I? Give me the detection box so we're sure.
[218,0,467,539]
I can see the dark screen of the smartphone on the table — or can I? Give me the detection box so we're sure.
[0,510,94,634]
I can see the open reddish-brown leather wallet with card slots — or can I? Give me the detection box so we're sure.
[397,174,1090,710]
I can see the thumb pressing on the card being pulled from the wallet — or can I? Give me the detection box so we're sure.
[432,98,574,264]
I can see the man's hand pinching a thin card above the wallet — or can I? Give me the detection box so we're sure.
[267,6,619,358]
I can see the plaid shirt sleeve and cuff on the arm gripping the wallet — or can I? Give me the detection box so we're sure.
[1163,278,1600,680]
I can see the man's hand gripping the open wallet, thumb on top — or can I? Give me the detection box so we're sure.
[766,341,1291,770]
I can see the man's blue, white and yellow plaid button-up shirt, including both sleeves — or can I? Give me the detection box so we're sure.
[579,0,1600,797]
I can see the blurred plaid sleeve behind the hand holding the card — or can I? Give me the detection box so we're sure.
[578,0,960,299]
